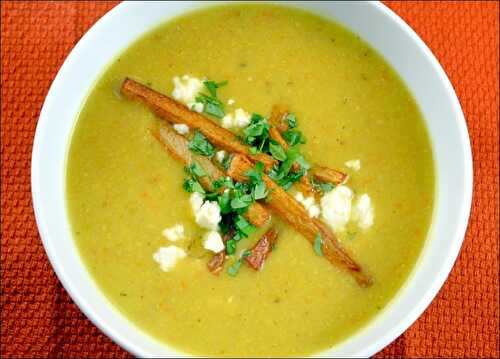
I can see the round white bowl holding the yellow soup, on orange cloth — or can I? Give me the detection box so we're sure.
[31,1,472,357]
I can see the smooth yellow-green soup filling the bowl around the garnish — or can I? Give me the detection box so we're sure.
[67,5,434,356]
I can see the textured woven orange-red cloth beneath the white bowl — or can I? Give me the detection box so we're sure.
[0,1,499,357]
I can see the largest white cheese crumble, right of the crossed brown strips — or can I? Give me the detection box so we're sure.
[321,185,352,231]
